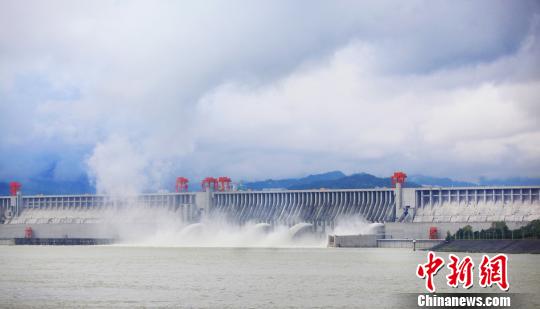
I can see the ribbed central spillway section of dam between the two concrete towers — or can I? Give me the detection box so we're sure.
[212,189,396,225]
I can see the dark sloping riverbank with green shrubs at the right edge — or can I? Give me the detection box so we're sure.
[431,239,540,254]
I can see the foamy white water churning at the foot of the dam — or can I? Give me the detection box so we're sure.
[114,215,382,248]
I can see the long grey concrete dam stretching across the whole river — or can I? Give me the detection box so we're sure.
[0,175,540,239]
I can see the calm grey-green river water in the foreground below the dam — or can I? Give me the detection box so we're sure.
[0,246,540,308]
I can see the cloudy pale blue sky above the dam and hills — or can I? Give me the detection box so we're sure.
[0,0,540,192]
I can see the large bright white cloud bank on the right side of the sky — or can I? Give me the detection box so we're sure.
[199,31,540,177]
